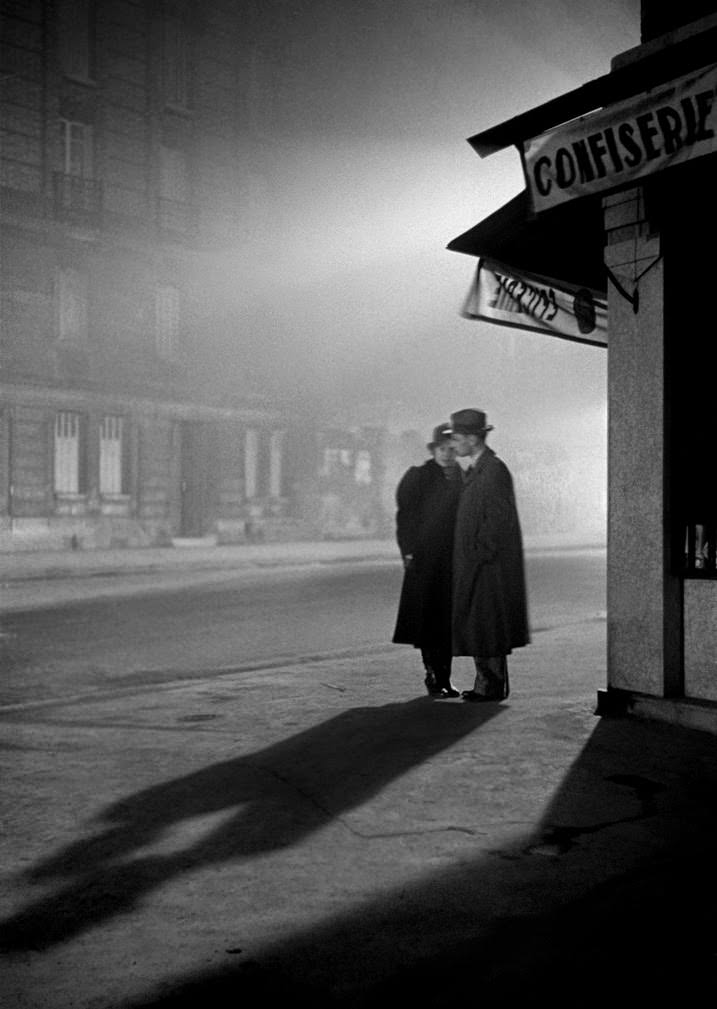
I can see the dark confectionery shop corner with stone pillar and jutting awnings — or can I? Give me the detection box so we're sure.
[452,0,717,731]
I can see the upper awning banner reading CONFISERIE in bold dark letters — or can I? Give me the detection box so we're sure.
[522,66,717,211]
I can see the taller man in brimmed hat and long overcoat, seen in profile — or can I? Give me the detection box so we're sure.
[451,410,530,701]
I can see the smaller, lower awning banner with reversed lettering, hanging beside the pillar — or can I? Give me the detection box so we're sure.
[462,259,607,347]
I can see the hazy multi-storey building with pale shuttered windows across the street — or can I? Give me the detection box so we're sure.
[0,0,387,549]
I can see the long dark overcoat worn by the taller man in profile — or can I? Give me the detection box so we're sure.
[453,448,530,657]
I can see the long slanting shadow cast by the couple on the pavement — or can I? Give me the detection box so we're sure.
[0,697,501,950]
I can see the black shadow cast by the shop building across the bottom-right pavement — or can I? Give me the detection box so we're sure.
[110,720,717,1009]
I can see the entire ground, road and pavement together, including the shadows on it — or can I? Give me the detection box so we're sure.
[12,547,717,1009]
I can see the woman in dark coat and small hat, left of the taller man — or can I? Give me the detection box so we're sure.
[393,424,460,697]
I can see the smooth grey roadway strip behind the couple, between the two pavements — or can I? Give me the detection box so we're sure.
[0,550,605,706]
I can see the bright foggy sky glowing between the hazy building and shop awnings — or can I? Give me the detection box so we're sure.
[207,0,639,476]
